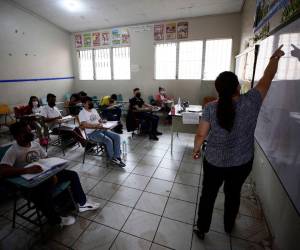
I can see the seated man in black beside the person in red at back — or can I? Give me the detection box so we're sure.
[128,88,162,141]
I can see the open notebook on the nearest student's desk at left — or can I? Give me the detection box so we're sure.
[21,157,68,180]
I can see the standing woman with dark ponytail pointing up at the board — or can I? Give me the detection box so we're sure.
[193,45,284,239]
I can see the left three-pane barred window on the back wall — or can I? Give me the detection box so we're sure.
[77,47,130,80]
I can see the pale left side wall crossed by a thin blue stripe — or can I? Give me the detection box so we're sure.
[0,0,73,105]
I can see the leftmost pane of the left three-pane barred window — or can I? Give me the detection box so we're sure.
[77,50,94,80]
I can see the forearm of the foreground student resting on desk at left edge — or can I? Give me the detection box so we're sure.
[0,164,43,179]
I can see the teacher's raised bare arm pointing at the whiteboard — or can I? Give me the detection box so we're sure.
[255,45,284,99]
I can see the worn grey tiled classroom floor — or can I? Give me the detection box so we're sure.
[0,127,270,250]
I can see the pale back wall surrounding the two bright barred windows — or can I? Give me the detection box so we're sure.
[73,14,240,103]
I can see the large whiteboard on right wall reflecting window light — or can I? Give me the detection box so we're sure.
[255,19,300,213]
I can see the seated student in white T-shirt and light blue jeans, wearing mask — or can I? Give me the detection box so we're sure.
[79,97,125,167]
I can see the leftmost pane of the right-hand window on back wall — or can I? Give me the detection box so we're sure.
[155,43,177,79]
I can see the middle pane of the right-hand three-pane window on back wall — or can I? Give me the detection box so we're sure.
[178,41,203,79]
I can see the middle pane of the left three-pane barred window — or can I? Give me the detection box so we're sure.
[94,49,111,80]
